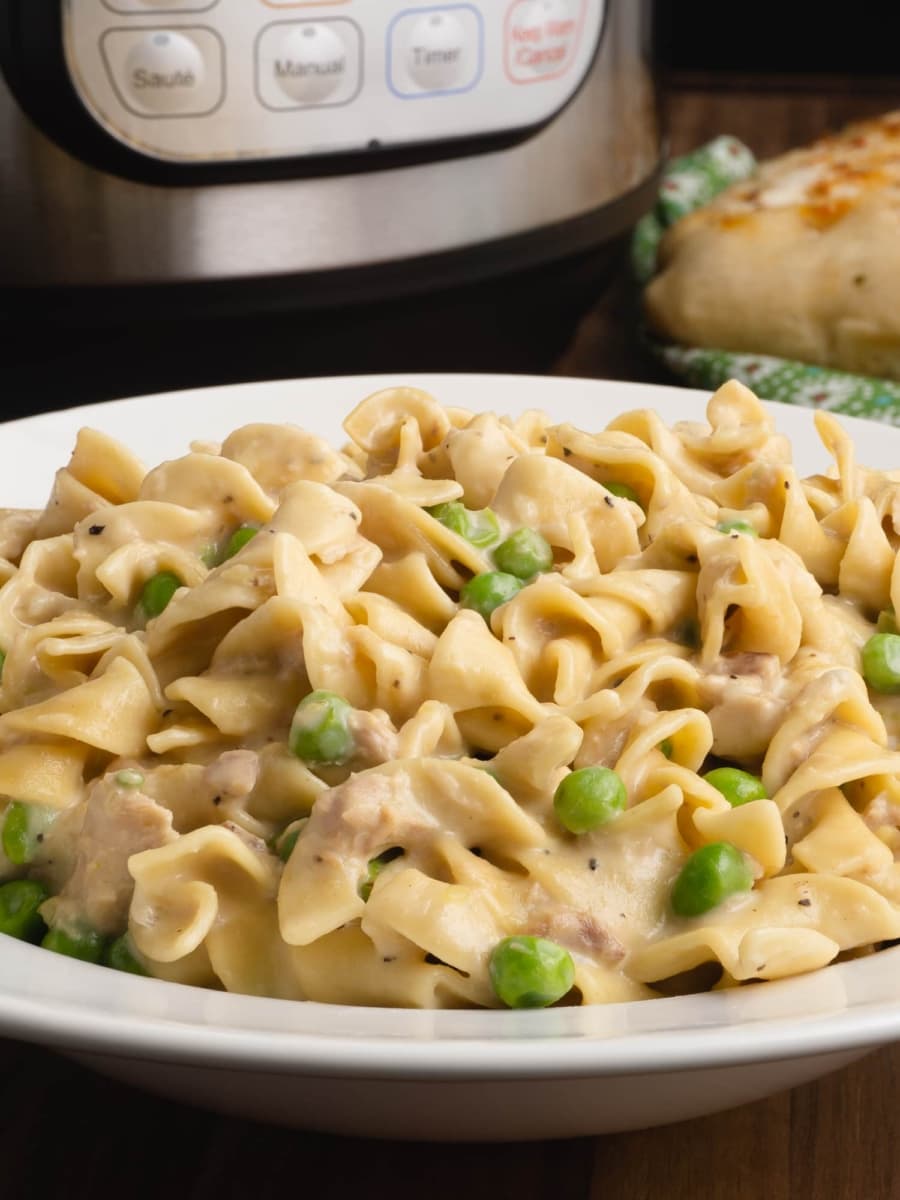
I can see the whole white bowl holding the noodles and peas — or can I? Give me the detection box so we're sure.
[0,374,900,1140]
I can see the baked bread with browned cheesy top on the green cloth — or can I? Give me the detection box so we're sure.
[644,112,900,379]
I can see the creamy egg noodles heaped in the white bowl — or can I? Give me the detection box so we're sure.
[0,383,900,1007]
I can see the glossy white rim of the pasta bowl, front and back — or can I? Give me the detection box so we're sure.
[0,372,900,1080]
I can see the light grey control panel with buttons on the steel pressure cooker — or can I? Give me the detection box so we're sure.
[61,0,606,164]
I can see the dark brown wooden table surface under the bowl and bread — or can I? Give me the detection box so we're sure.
[7,78,900,1200]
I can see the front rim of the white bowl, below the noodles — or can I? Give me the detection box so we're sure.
[0,938,900,1081]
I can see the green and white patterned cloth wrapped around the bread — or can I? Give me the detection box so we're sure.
[631,137,900,425]
